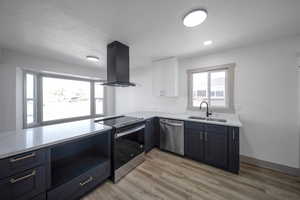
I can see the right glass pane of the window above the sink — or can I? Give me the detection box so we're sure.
[210,71,226,107]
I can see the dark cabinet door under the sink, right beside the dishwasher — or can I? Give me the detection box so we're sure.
[184,129,204,161]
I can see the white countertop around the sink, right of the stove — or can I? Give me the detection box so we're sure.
[126,111,242,127]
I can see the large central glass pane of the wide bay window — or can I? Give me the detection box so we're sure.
[42,77,91,121]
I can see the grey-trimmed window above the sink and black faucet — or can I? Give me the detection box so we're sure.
[187,64,234,112]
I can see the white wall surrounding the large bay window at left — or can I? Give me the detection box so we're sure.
[0,49,115,132]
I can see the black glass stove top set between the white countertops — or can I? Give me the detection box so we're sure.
[95,115,144,128]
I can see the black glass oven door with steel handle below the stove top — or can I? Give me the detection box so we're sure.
[114,123,145,170]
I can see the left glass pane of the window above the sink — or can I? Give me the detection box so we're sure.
[192,72,208,107]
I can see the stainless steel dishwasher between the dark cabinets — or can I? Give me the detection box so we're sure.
[159,119,184,155]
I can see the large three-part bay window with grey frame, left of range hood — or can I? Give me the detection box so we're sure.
[23,71,105,127]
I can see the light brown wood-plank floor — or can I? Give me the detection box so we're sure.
[82,149,300,200]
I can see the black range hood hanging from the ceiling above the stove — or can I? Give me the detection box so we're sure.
[103,41,135,87]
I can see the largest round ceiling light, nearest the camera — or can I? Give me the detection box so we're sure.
[182,9,207,27]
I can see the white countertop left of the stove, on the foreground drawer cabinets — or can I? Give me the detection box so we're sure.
[0,119,111,159]
